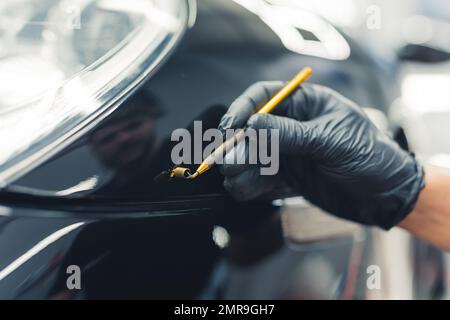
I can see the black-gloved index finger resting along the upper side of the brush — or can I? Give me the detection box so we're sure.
[219,81,284,132]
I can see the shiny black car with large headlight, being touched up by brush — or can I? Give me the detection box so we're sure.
[0,0,443,299]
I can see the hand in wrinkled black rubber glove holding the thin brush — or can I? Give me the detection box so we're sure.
[219,82,424,229]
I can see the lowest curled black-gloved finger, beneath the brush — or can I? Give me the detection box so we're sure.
[224,166,275,201]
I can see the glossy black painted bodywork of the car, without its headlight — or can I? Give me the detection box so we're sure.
[0,0,400,299]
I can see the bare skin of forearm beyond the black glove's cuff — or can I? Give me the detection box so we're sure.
[399,166,450,251]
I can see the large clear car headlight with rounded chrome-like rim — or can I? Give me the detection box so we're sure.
[0,0,195,187]
